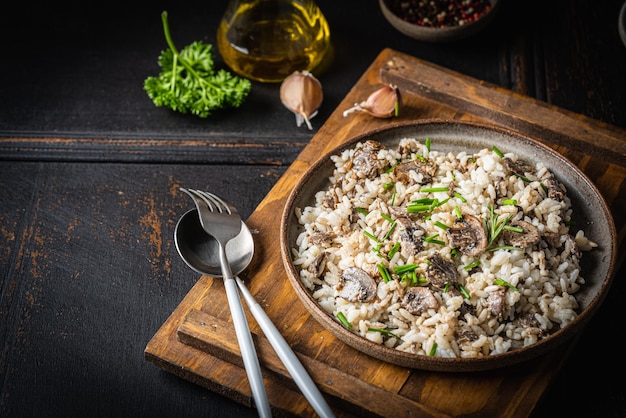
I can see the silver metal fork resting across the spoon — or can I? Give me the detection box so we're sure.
[180,187,272,418]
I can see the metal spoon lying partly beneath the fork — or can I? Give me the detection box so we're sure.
[174,209,335,418]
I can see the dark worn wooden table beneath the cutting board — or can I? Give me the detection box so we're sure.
[0,0,626,417]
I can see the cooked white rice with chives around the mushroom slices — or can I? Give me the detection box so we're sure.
[292,138,596,358]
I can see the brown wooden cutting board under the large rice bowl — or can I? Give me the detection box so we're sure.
[145,49,626,417]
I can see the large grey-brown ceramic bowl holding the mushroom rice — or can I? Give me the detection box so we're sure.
[280,120,617,372]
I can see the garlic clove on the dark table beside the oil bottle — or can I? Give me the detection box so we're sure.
[280,71,324,129]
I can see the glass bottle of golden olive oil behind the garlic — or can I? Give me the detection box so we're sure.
[217,0,330,82]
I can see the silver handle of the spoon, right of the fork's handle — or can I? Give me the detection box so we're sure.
[235,276,335,418]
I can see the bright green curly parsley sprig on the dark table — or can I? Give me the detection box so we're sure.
[144,11,251,118]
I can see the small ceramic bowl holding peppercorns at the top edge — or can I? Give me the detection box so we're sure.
[379,0,500,43]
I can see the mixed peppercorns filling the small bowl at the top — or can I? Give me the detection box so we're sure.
[385,0,491,28]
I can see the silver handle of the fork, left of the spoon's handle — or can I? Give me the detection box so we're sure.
[220,250,272,418]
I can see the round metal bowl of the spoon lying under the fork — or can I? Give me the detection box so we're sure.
[174,209,254,278]
